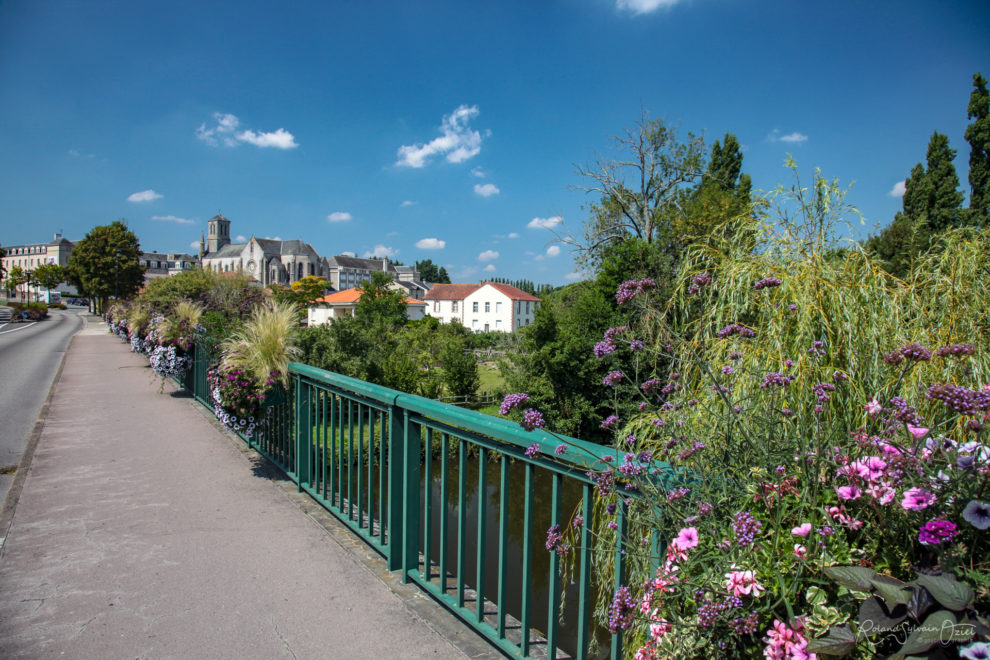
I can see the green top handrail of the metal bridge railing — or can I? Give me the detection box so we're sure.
[289,362,628,470]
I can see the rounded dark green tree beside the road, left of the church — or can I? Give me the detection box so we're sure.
[69,220,144,311]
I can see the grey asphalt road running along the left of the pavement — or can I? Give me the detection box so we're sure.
[0,307,85,503]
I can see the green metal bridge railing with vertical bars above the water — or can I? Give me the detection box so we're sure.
[182,347,660,658]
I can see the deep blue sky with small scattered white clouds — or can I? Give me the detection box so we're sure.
[0,0,990,284]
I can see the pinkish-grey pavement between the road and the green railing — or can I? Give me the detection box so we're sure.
[0,325,476,658]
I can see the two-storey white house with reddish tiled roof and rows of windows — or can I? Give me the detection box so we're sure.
[423,282,540,332]
